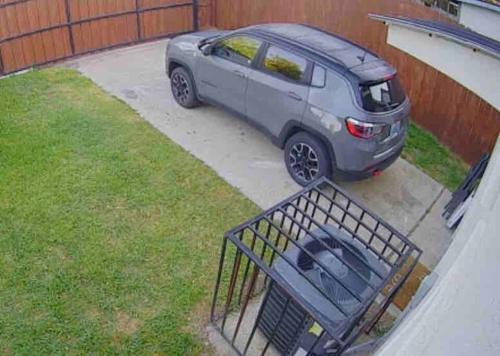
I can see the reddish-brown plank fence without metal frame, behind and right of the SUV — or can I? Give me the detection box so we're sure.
[215,0,500,163]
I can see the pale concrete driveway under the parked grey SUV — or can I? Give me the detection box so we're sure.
[65,40,451,268]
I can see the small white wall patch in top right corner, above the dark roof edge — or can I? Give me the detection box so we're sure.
[459,3,500,42]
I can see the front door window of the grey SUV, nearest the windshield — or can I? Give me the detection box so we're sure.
[214,36,262,66]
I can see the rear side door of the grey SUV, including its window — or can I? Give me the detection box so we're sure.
[246,44,311,136]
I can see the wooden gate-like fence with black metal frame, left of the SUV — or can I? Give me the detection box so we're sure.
[0,0,213,75]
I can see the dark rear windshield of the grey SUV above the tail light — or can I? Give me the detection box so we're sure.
[360,77,406,112]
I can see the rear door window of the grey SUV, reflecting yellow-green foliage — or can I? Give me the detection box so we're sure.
[263,45,307,82]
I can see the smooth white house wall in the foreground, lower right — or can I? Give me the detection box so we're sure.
[376,138,500,356]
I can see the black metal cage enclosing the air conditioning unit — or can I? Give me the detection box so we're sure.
[211,179,422,355]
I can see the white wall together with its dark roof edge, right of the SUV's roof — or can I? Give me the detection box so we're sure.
[370,15,500,110]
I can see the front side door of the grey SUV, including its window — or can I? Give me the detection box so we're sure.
[197,35,262,114]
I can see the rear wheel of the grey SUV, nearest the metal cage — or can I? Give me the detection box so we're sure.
[285,132,332,187]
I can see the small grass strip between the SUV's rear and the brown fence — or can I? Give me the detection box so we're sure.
[402,123,469,191]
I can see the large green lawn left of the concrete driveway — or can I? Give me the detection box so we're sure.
[0,69,259,355]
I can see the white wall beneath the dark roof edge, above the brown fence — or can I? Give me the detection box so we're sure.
[387,24,500,110]
